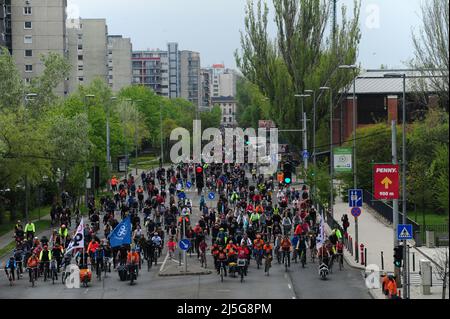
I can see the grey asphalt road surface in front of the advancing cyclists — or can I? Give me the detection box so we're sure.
[0,170,370,299]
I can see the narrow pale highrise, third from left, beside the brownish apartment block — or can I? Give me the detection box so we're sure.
[108,35,133,92]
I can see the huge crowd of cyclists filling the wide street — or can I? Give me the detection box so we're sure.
[4,164,343,285]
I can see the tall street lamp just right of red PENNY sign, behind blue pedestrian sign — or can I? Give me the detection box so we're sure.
[384,73,409,298]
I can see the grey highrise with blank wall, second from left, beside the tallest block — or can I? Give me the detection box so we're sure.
[67,19,108,92]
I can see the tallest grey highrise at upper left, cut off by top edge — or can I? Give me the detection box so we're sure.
[9,0,67,95]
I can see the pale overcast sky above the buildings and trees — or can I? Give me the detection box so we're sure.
[68,0,427,69]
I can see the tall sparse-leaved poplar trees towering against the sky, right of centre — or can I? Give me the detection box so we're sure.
[235,0,360,145]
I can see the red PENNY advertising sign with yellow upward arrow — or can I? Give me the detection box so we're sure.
[373,164,400,199]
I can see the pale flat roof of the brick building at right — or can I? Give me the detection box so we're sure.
[340,69,445,95]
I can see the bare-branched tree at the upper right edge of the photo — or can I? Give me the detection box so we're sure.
[411,0,449,107]
